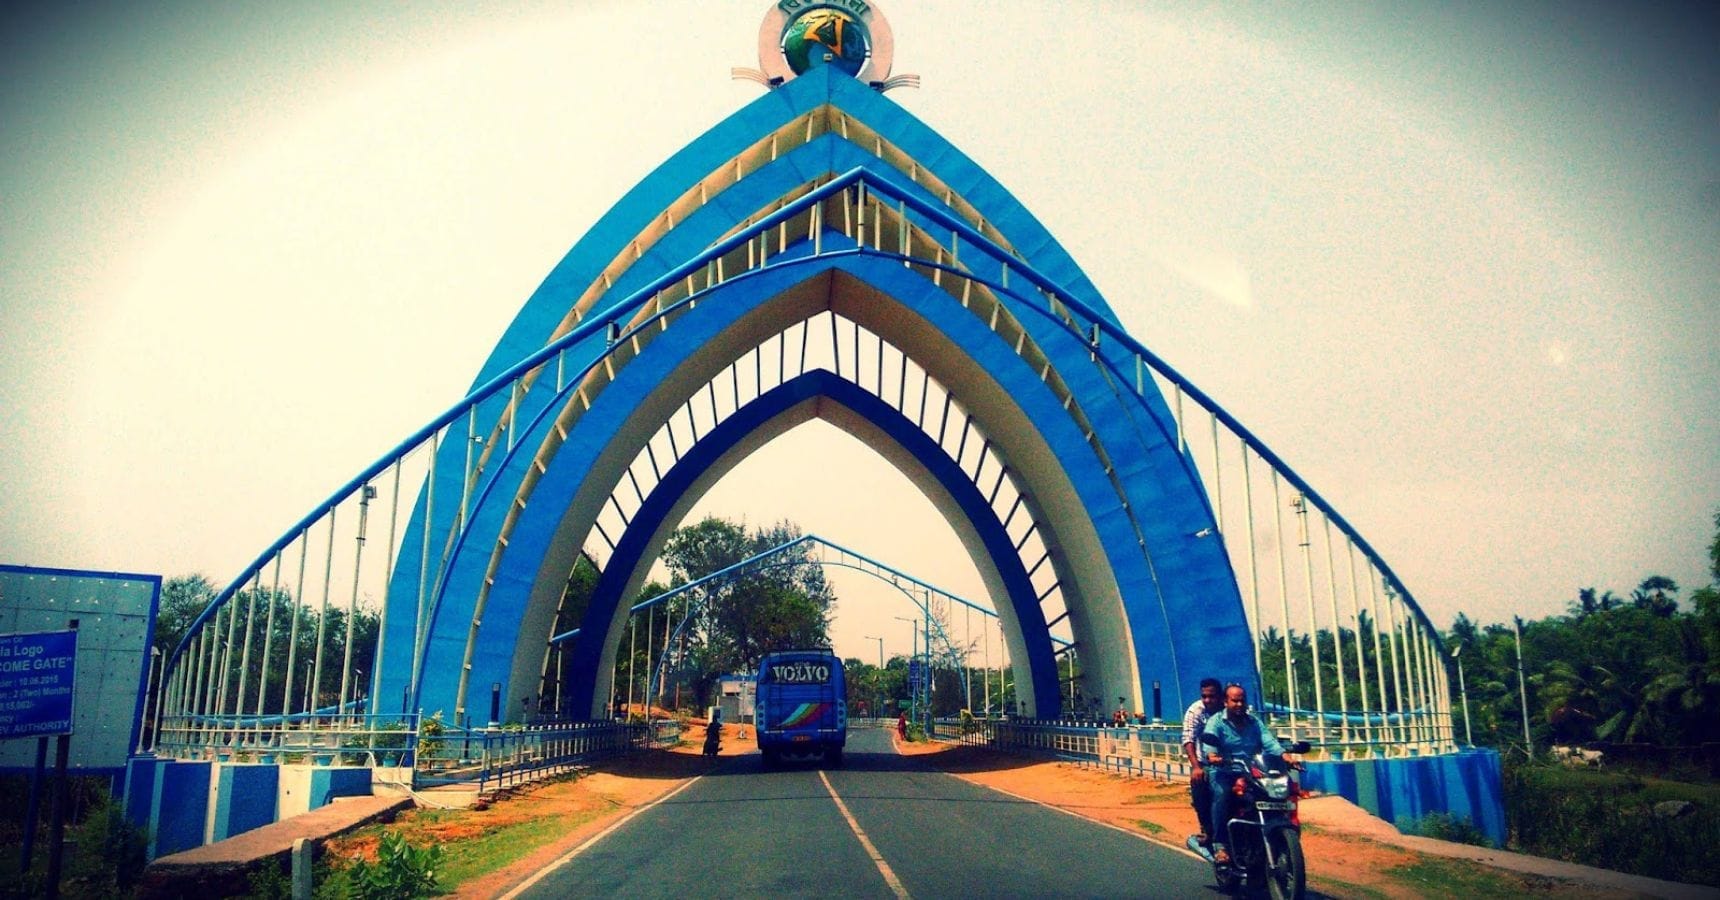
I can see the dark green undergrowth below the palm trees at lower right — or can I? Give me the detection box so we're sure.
[1502,762,1720,886]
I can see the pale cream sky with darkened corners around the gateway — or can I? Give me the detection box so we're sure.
[0,0,1720,659]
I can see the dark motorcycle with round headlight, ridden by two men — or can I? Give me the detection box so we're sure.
[1189,735,1307,900]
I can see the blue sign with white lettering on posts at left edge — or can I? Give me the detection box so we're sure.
[0,620,77,897]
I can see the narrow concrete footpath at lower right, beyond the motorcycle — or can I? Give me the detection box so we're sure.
[1300,795,1720,900]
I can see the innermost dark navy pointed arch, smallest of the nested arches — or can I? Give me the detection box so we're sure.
[562,370,1060,712]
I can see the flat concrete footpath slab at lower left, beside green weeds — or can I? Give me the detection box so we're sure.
[138,793,413,898]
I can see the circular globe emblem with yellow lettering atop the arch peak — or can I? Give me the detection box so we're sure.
[759,0,894,84]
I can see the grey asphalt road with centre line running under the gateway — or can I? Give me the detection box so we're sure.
[505,730,1219,900]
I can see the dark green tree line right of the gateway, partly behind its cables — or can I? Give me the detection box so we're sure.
[1259,515,1720,750]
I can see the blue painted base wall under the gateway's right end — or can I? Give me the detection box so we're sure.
[1302,749,1505,847]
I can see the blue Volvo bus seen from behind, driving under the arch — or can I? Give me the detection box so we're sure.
[753,649,848,766]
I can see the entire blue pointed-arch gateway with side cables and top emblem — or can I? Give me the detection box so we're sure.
[165,0,1452,750]
